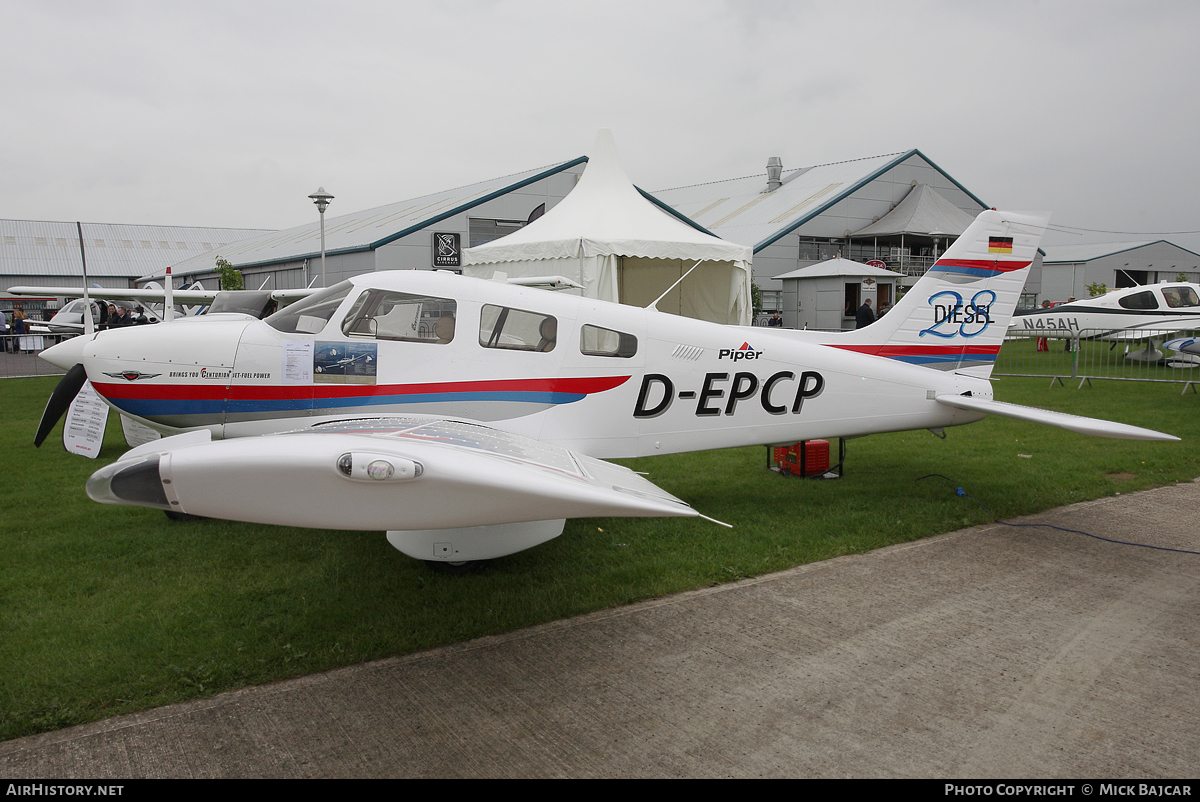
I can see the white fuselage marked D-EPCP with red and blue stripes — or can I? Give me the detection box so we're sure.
[56,271,991,457]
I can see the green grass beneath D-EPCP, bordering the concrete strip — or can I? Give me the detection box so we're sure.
[0,378,1200,740]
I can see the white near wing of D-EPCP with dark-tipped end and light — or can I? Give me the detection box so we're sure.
[88,415,700,531]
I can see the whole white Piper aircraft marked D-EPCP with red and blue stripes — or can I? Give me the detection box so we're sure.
[42,206,1177,564]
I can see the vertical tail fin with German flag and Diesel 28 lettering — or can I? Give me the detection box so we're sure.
[824,210,1050,378]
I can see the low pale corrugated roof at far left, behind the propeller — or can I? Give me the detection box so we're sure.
[0,220,269,279]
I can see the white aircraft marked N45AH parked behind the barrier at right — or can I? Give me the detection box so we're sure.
[1008,281,1200,360]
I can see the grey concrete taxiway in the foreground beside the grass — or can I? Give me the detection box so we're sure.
[0,483,1200,779]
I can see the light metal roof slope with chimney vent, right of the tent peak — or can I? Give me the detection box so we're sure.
[654,150,902,250]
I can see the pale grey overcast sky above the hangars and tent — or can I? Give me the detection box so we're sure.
[9,0,1200,251]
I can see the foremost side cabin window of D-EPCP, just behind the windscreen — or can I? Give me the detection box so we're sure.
[342,289,457,346]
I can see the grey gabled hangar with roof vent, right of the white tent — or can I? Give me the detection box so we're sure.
[654,150,998,328]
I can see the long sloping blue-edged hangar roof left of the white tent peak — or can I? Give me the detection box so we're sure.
[164,157,587,275]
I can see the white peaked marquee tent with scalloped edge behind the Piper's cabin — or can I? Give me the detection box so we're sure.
[463,128,752,325]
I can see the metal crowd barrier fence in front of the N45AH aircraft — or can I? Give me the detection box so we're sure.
[992,329,1200,393]
